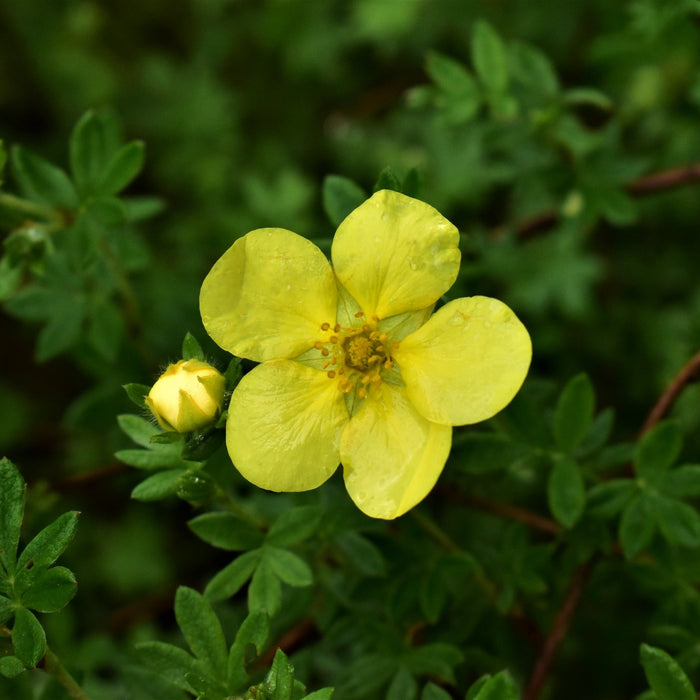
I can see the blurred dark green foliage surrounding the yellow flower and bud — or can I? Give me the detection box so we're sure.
[0,0,700,700]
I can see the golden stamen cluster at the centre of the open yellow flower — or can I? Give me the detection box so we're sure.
[315,312,398,399]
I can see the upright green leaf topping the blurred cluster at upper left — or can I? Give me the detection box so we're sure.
[69,110,114,196]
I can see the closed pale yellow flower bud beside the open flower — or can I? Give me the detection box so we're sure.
[146,360,226,433]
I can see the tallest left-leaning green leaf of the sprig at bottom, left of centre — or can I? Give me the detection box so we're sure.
[175,586,228,680]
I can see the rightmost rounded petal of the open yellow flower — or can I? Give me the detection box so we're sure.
[393,297,532,425]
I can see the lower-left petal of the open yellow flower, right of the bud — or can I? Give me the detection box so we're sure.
[226,360,348,491]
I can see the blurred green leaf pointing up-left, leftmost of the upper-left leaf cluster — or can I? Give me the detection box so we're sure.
[12,146,78,210]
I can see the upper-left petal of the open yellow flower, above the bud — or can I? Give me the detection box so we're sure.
[199,228,337,362]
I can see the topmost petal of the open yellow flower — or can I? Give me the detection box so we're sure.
[331,190,460,318]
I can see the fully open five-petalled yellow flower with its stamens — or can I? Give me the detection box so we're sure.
[200,190,532,519]
